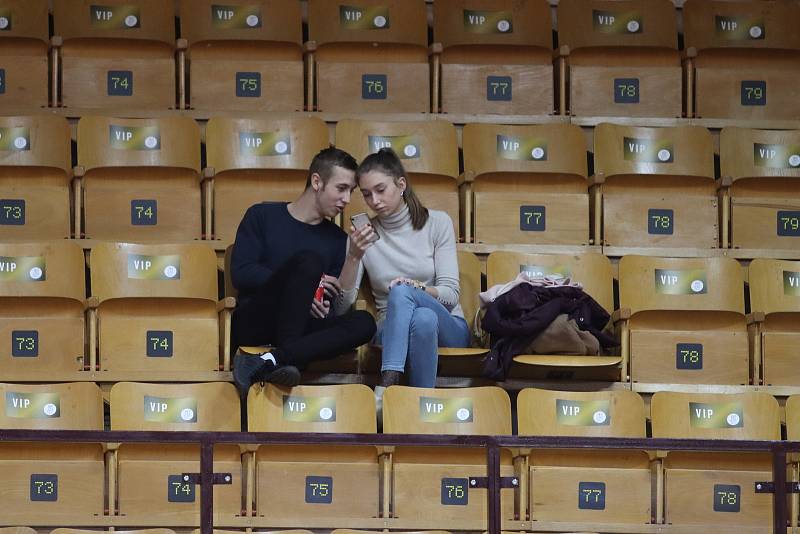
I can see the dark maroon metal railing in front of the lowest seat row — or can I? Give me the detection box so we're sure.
[0,430,800,534]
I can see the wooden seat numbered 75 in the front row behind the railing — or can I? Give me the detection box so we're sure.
[247,384,380,528]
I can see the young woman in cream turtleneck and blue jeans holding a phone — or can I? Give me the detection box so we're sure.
[337,149,470,406]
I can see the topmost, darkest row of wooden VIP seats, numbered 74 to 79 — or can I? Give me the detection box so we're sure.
[0,0,800,119]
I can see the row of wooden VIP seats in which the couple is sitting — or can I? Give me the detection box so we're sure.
[0,241,800,386]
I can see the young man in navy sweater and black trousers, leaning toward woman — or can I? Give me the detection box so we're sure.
[231,148,375,398]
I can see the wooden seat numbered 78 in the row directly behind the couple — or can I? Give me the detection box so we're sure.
[592,124,719,254]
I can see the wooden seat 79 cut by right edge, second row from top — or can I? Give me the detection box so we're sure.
[719,127,800,253]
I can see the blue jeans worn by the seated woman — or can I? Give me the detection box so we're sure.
[375,284,470,388]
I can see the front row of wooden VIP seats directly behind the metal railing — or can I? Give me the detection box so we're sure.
[0,382,800,532]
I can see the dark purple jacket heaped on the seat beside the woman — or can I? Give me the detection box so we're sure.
[481,284,617,380]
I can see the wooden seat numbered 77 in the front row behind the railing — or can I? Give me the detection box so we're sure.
[517,388,651,529]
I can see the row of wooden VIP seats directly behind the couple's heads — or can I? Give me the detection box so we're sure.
[0,116,800,253]
